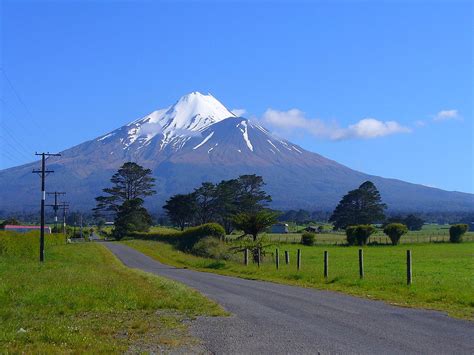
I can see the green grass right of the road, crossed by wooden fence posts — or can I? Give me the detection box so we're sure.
[123,240,474,320]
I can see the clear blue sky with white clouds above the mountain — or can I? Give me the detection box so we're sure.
[0,0,474,192]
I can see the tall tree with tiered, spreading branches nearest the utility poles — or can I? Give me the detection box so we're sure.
[94,162,156,216]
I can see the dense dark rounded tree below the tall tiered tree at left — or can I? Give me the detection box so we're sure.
[113,198,152,240]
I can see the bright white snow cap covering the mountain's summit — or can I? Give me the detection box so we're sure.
[98,91,235,149]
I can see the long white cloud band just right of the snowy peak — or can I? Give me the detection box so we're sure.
[262,109,411,140]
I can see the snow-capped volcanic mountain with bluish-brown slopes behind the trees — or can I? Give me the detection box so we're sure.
[0,92,474,211]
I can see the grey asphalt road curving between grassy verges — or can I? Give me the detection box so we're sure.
[105,243,474,354]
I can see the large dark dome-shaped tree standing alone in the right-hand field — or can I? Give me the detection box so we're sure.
[329,181,387,229]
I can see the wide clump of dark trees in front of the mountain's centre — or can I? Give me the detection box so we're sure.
[163,175,272,234]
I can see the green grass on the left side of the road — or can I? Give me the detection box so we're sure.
[0,241,225,353]
